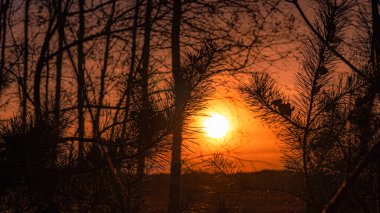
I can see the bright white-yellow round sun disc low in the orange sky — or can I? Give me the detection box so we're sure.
[203,113,230,139]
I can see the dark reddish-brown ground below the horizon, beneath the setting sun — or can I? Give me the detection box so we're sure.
[144,171,304,213]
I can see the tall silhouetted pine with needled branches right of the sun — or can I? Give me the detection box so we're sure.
[242,0,378,212]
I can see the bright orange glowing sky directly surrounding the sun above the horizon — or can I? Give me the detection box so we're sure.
[183,69,298,171]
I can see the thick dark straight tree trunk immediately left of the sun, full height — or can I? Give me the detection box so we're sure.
[168,0,184,213]
